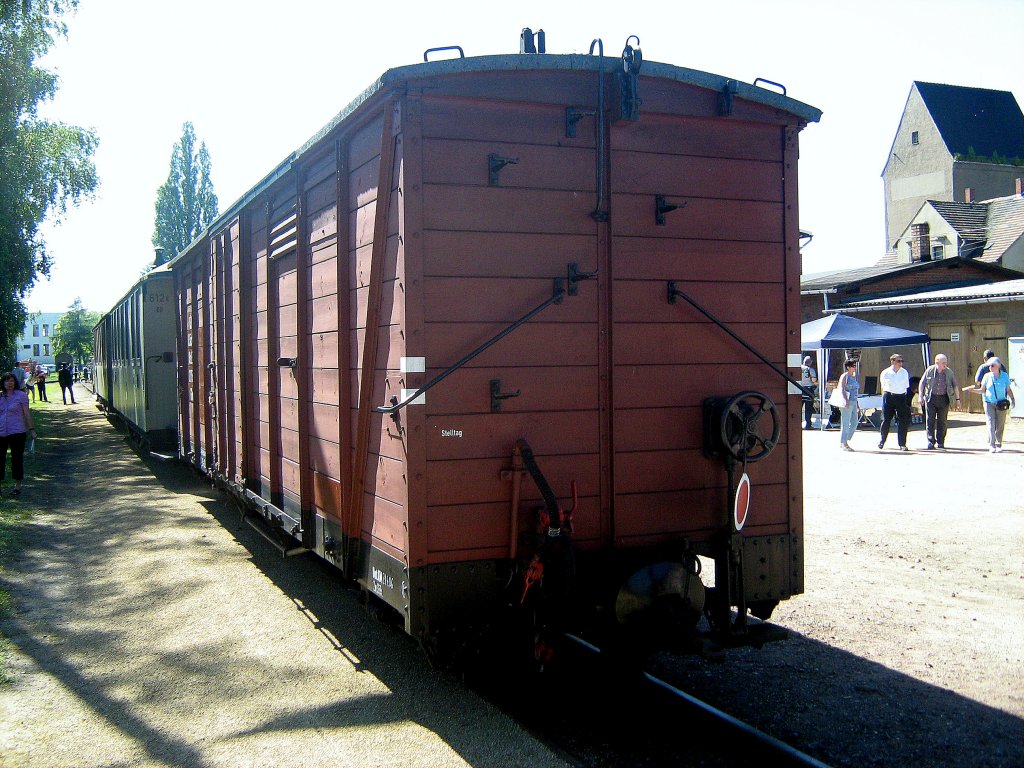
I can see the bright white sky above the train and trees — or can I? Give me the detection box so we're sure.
[26,0,1024,312]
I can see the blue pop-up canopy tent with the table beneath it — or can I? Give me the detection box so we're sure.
[800,312,931,429]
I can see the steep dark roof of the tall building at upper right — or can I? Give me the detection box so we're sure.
[914,81,1024,160]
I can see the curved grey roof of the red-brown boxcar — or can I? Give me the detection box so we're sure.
[168,53,821,265]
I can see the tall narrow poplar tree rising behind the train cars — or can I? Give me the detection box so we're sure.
[150,120,217,266]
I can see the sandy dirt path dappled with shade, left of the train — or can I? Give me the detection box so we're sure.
[0,388,564,768]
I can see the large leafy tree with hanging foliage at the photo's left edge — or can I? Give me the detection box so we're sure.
[0,0,98,360]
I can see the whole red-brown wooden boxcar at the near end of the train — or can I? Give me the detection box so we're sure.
[172,36,819,659]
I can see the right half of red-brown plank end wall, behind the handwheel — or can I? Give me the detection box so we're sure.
[611,105,787,545]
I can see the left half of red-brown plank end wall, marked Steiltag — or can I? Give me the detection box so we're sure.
[419,81,601,562]
